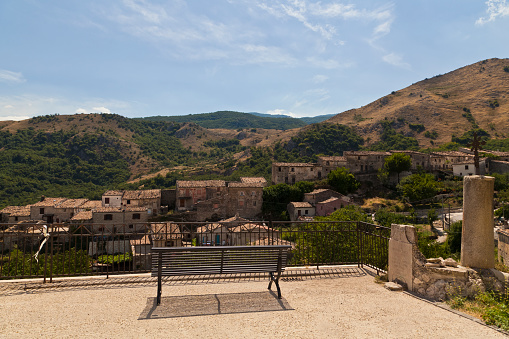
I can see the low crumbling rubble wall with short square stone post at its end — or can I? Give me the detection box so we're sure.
[388,225,508,300]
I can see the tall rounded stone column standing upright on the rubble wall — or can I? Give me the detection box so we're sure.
[461,175,495,268]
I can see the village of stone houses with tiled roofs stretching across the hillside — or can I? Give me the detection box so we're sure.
[0,149,509,229]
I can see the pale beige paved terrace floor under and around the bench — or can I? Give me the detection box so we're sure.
[0,267,505,339]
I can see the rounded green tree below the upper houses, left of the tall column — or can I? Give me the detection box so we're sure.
[398,173,439,201]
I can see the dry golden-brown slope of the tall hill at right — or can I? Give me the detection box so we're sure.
[327,59,509,147]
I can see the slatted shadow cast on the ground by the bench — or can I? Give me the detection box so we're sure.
[138,291,293,320]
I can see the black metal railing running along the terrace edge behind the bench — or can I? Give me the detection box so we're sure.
[0,220,390,282]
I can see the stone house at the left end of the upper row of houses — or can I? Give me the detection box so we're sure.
[272,163,322,184]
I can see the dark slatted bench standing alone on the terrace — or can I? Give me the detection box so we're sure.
[152,245,291,305]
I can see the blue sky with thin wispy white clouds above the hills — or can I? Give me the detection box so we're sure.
[0,0,509,120]
